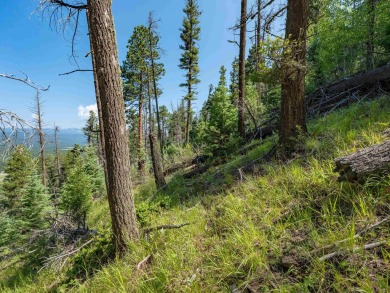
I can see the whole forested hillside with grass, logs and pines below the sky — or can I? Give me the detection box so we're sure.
[0,0,390,293]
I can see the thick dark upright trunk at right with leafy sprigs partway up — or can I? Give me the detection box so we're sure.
[279,0,309,148]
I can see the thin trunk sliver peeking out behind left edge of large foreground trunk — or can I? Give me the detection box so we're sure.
[86,9,108,188]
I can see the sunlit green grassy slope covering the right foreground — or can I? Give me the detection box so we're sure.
[0,97,390,292]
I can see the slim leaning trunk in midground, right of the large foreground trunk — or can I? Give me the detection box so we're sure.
[148,68,166,189]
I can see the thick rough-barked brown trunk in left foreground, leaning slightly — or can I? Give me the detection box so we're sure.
[88,0,139,256]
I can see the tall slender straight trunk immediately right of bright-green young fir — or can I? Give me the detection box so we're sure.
[237,0,247,138]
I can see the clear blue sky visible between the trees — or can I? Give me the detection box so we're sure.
[0,0,260,128]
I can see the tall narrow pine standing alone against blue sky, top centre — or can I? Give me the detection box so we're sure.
[179,0,201,144]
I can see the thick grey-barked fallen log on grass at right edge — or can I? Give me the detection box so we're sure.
[334,140,390,182]
